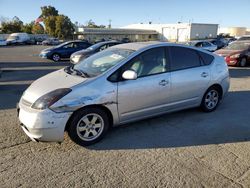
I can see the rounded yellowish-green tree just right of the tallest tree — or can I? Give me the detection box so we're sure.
[55,15,74,39]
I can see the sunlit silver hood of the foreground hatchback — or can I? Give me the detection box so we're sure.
[22,69,87,103]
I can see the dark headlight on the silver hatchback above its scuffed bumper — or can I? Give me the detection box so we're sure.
[31,88,72,110]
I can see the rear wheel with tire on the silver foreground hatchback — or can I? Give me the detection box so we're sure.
[200,87,221,112]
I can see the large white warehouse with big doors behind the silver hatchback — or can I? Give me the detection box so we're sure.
[122,23,218,42]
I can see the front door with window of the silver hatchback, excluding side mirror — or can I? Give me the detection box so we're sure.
[118,47,171,122]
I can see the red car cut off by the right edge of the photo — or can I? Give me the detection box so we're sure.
[215,40,250,67]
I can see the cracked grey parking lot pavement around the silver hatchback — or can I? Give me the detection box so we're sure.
[0,46,250,188]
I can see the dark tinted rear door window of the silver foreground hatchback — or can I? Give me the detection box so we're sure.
[170,46,201,71]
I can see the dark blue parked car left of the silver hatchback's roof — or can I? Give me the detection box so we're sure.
[39,41,91,61]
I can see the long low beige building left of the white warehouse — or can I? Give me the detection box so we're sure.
[74,28,158,42]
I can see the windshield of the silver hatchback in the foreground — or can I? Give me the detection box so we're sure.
[74,48,134,77]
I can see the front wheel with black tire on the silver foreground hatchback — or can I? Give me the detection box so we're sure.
[68,107,109,146]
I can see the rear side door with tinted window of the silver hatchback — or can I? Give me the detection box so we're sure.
[169,46,210,108]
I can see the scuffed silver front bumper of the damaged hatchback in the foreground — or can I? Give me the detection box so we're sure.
[18,105,71,142]
